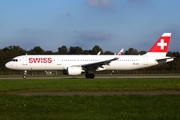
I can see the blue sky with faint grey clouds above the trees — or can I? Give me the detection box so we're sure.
[0,0,180,53]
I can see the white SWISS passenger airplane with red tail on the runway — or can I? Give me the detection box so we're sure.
[5,33,174,79]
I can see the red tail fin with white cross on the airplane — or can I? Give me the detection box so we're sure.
[149,33,171,52]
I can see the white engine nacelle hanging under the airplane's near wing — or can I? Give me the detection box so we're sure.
[63,67,82,75]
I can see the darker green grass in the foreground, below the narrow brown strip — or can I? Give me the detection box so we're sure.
[0,95,180,120]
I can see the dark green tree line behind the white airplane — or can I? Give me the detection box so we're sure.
[0,45,180,73]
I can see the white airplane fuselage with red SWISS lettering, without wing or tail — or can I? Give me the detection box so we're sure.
[6,55,166,70]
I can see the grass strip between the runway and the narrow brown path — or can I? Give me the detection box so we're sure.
[0,78,180,92]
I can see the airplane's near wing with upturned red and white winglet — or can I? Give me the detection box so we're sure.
[81,49,124,71]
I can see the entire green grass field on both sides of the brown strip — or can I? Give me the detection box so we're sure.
[0,78,180,120]
